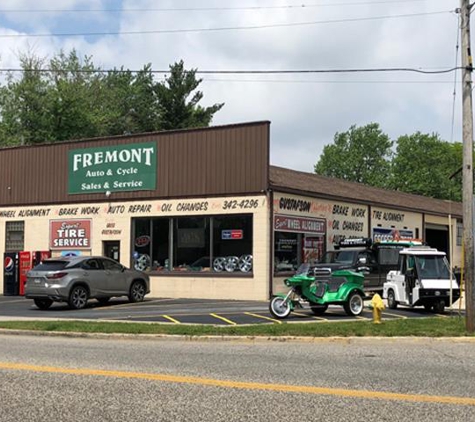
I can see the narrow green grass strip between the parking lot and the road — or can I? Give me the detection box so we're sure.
[0,316,473,337]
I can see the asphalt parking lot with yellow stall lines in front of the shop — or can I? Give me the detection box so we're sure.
[0,296,458,326]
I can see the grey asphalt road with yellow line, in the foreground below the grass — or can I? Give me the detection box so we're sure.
[0,335,475,422]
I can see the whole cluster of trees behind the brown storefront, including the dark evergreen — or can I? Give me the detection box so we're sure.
[0,50,223,146]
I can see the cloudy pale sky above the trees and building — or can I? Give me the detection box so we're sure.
[0,0,461,172]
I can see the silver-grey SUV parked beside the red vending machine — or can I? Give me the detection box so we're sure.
[25,256,150,309]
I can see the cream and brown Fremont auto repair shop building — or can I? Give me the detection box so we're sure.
[0,121,462,300]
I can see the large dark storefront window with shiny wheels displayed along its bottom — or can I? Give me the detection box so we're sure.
[132,215,253,274]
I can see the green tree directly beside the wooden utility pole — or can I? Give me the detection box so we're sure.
[390,132,462,201]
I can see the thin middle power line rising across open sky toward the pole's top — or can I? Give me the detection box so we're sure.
[0,10,454,38]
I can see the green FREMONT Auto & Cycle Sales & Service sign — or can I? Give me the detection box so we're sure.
[68,142,157,194]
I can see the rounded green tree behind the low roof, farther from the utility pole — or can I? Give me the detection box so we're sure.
[315,123,393,188]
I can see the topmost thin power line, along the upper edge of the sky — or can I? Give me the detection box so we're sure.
[0,0,436,13]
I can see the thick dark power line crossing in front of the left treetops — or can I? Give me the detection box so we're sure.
[0,67,461,75]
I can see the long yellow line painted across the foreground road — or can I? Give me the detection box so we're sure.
[0,362,475,406]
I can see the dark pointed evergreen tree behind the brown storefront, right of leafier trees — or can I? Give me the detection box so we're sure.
[155,61,224,130]
